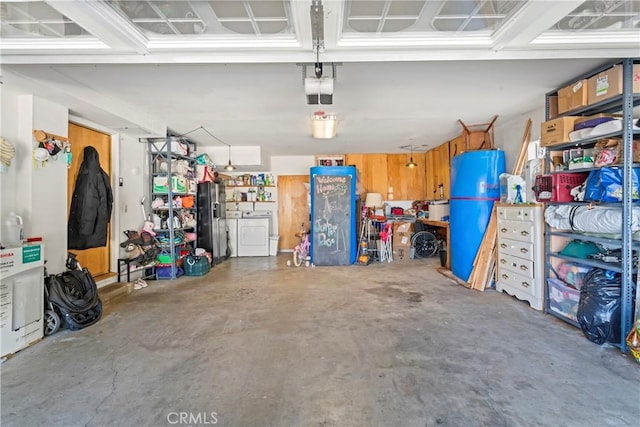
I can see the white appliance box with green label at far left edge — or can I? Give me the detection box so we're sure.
[0,245,44,357]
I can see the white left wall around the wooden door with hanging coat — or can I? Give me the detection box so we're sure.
[0,84,158,273]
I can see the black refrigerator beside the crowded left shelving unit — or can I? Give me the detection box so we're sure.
[197,182,227,265]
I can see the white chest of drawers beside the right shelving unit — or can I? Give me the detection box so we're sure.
[496,204,544,310]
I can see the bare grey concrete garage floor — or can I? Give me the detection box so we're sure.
[1,254,640,427]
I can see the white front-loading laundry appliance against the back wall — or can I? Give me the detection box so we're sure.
[238,211,271,256]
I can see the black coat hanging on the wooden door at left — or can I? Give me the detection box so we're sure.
[67,147,113,249]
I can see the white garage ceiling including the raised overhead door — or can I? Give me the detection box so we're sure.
[0,0,640,155]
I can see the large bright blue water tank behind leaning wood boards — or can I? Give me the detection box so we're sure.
[449,150,505,281]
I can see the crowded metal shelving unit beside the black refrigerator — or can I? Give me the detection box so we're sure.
[143,134,197,279]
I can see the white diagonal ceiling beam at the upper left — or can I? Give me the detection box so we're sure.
[46,0,147,54]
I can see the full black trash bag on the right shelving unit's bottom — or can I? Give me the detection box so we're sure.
[578,268,622,345]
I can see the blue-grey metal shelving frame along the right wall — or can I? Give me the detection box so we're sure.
[545,58,640,352]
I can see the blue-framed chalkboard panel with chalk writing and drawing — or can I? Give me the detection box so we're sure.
[311,166,357,265]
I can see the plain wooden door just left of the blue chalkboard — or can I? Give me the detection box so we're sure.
[278,175,310,250]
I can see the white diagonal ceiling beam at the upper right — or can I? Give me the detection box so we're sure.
[493,0,584,50]
